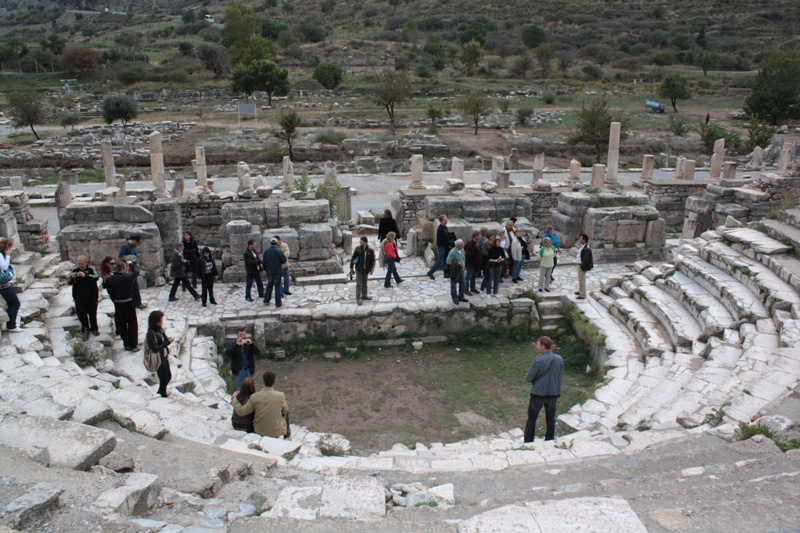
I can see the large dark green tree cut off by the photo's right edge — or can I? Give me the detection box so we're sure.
[744,50,800,124]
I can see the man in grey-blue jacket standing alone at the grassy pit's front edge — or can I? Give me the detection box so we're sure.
[524,337,564,442]
